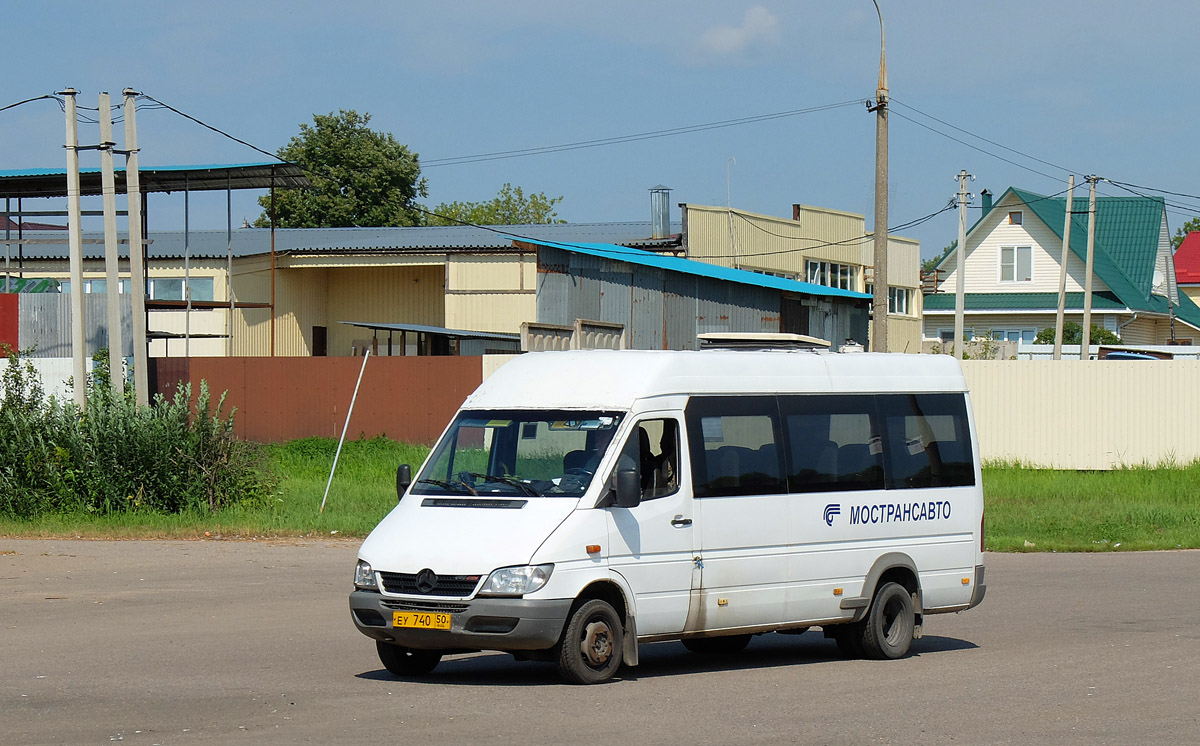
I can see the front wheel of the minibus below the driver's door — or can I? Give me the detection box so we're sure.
[557,598,625,684]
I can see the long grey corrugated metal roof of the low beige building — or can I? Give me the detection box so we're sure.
[0,221,678,259]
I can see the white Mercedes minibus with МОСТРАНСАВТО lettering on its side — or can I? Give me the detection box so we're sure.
[349,349,985,684]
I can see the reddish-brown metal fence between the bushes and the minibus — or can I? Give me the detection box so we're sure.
[152,356,482,444]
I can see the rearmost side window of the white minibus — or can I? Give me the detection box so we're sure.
[878,393,974,489]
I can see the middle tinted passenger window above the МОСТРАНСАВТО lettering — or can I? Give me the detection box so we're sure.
[780,396,883,493]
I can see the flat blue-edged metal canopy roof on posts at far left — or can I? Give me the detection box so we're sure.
[0,163,312,198]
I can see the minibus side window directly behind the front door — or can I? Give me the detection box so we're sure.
[686,397,786,498]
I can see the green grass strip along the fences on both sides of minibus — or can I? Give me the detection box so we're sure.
[0,438,1200,552]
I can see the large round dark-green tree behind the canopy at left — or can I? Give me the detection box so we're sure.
[254,109,428,228]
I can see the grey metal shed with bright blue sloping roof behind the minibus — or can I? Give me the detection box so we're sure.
[529,242,871,350]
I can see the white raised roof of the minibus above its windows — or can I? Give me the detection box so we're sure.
[463,350,967,410]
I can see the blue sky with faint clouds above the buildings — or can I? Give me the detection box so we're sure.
[0,0,1200,255]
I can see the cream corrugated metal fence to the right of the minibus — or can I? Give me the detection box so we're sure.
[962,360,1200,469]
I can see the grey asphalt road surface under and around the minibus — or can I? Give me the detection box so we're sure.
[0,539,1200,746]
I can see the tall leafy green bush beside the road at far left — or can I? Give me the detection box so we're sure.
[0,350,275,518]
